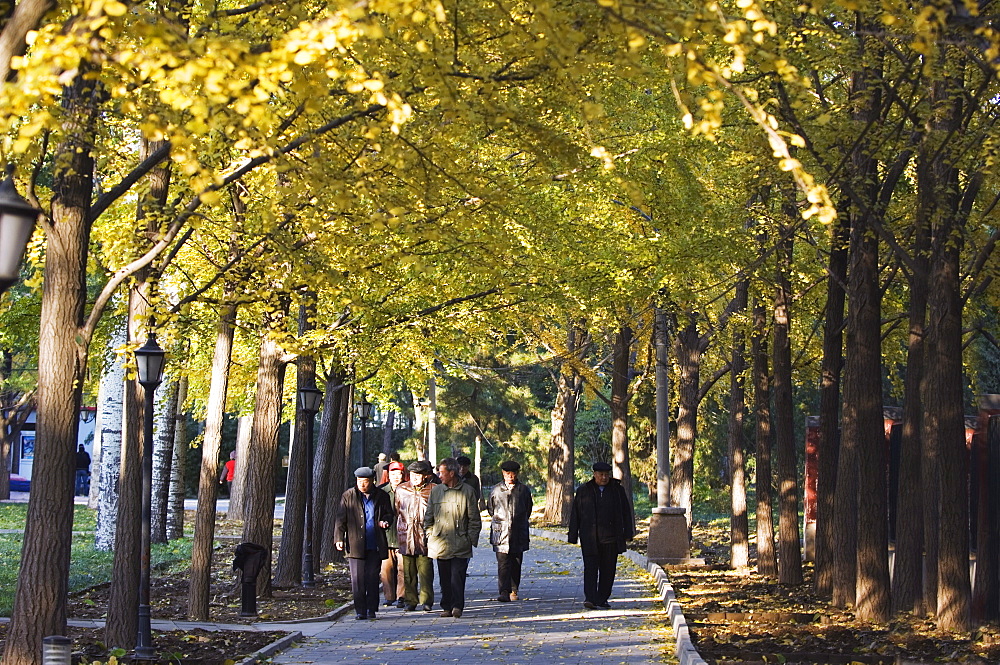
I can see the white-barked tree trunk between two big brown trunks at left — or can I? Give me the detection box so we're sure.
[90,325,128,552]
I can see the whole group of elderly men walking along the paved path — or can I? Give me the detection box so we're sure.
[334,457,635,619]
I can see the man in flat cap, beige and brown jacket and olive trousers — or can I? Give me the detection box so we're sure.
[396,460,434,612]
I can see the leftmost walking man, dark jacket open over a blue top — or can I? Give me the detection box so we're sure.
[333,466,395,619]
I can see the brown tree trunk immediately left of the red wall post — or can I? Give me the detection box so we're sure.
[773,226,802,584]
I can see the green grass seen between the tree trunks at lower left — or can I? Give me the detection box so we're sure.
[0,534,191,617]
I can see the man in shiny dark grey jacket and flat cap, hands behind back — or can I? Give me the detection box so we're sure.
[486,460,531,603]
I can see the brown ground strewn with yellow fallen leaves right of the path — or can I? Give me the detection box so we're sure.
[669,526,1000,664]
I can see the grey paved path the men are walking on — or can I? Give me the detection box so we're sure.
[272,534,673,665]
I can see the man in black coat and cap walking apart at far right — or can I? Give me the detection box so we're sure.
[569,462,635,610]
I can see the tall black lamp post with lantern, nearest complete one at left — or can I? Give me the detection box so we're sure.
[135,332,166,661]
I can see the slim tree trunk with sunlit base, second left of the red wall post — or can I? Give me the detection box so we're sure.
[750,302,778,577]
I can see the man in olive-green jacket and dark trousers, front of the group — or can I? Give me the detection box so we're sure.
[424,457,483,618]
